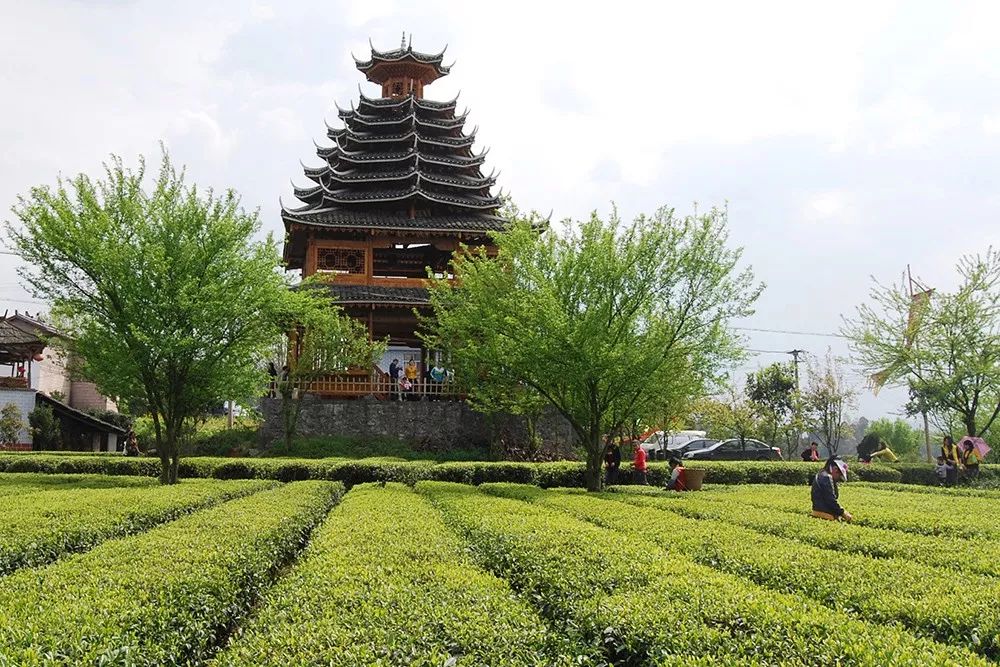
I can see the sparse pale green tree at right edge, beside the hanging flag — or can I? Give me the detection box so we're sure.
[844,248,1000,435]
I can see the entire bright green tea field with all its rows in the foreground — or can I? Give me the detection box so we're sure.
[0,472,1000,667]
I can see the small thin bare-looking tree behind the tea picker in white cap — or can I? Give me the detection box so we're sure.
[802,352,857,456]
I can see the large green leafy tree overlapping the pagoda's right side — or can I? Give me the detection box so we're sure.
[424,208,762,490]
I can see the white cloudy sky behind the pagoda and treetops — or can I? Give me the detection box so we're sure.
[0,0,1000,417]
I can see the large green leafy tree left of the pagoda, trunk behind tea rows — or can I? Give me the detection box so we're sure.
[7,153,300,484]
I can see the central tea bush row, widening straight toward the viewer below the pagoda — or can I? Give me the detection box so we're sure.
[213,483,580,667]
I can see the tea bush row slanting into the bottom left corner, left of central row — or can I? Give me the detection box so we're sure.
[0,482,343,665]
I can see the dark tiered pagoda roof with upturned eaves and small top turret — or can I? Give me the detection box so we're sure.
[282,38,506,268]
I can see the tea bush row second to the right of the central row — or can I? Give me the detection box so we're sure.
[500,487,1000,658]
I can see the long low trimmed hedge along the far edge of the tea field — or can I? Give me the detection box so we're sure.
[0,453,1000,488]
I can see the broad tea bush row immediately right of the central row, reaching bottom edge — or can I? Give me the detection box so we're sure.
[417,482,986,665]
